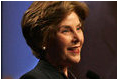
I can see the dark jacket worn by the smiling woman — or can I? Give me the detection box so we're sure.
[21,60,75,79]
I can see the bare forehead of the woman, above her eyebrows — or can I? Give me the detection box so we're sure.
[60,12,81,26]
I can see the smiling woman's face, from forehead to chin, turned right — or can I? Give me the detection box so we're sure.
[48,12,84,65]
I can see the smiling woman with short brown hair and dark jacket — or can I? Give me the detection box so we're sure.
[21,1,88,79]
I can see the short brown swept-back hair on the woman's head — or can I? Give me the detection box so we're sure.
[22,1,88,59]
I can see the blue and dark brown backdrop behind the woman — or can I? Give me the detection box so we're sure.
[1,1,117,79]
